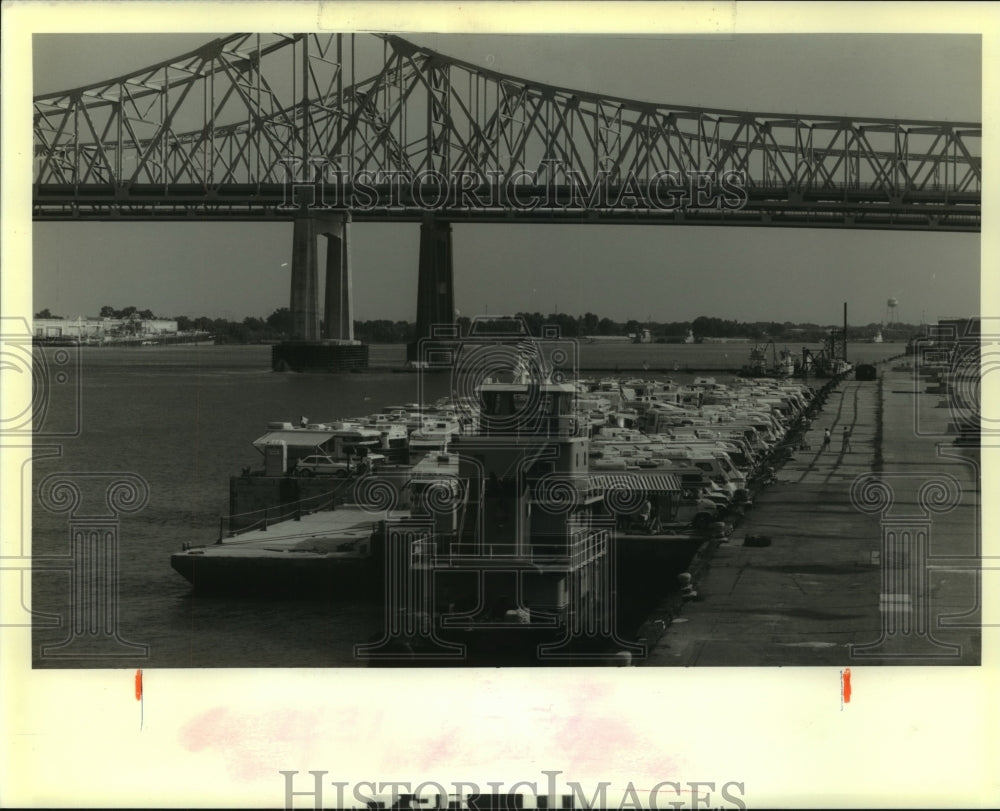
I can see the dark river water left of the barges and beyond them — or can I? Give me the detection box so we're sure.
[31,343,903,668]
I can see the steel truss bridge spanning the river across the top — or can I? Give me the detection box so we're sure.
[33,34,982,346]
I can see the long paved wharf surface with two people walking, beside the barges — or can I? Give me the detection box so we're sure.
[645,361,981,667]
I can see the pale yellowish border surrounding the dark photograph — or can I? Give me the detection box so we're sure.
[0,2,1000,807]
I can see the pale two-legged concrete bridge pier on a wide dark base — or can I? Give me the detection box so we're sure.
[271,212,368,372]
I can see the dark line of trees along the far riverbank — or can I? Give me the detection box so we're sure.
[35,305,920,344]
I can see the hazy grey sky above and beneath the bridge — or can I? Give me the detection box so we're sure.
[34,35,981,323]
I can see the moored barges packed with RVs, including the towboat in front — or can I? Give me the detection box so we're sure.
[171,318,819,664]
